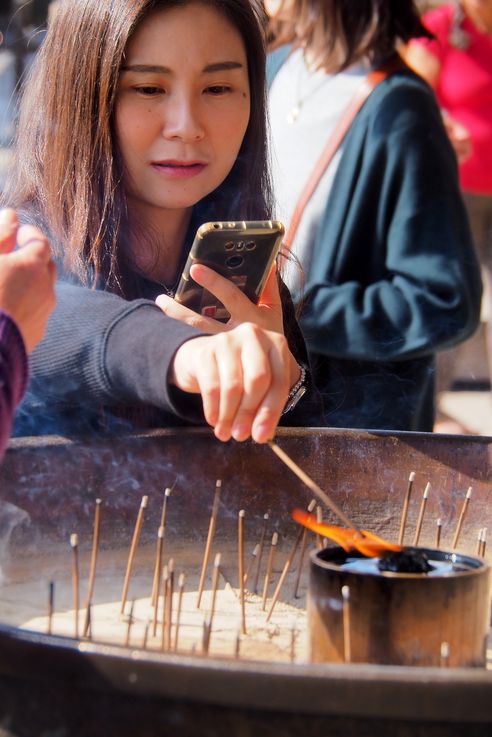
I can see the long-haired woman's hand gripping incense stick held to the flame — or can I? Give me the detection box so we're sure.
[171,323,292,443]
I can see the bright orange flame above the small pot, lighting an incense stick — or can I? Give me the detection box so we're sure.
[292,509,403,558]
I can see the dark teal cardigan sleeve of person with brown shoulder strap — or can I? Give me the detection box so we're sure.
[302,78,481,361]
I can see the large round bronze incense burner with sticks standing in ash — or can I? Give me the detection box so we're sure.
[0,429,492,737]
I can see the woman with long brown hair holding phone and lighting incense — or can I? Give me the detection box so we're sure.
[4,0,314,442]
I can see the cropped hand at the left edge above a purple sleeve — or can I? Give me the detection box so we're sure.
[0,209,56,353]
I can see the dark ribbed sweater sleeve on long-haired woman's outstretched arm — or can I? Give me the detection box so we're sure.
[30,281,201,414]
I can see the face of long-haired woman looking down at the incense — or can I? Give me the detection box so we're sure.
[114,2,250,219]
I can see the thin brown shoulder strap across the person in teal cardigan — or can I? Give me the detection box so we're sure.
[283,60,403,251]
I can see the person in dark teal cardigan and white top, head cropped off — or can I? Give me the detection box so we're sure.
[269,0,481,431]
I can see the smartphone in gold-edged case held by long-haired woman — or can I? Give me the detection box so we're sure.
[175,220,284,322]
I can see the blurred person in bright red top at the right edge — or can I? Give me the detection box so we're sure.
[405,0,492,426]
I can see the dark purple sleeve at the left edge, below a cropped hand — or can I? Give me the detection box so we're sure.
[0,310,28,458]
